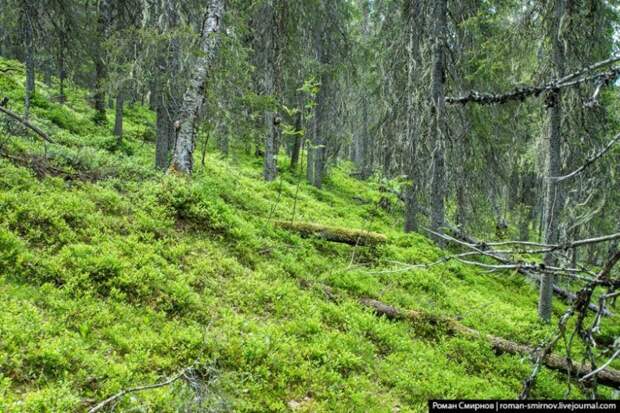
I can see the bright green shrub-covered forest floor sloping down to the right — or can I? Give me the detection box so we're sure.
[0,60,618,412]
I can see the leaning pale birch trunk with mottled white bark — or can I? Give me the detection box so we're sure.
[171,0,224,174]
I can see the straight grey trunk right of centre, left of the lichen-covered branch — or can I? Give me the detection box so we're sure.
[430,0,448,244]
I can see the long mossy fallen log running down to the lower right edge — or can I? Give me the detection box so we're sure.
[358,298,620,389]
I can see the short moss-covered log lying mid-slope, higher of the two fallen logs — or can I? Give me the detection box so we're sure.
[275,221,387,246]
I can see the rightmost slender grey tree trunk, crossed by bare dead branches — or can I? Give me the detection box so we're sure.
[538,0,565,322]
